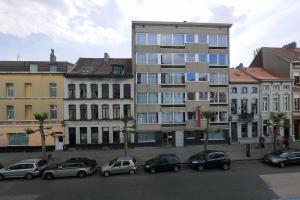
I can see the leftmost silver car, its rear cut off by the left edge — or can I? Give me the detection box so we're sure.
[0,158,48,180]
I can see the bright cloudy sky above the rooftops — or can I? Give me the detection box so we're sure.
[0,0,300,67]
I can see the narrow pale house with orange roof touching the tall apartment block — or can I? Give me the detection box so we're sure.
[229,68,261,143]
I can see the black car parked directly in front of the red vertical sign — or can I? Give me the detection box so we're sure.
[189,150,231,171]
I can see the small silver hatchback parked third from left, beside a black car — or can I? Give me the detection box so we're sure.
[101,156,137,177]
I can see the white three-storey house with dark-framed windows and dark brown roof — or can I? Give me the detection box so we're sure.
[64,53,134,148]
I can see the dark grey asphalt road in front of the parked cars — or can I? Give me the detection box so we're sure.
[0,161,300,200]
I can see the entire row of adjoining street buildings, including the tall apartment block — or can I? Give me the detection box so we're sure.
[0,21,300,151]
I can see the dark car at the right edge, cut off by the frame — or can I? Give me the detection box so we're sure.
[263,149,300,167]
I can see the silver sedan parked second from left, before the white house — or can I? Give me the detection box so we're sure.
[43,162,93,180]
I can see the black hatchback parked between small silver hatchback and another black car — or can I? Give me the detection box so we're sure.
[145,154,181,173]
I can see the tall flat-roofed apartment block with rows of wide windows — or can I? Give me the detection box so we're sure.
[132,21,231,146]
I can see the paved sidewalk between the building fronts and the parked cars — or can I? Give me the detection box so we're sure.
[0,142,300,165]
